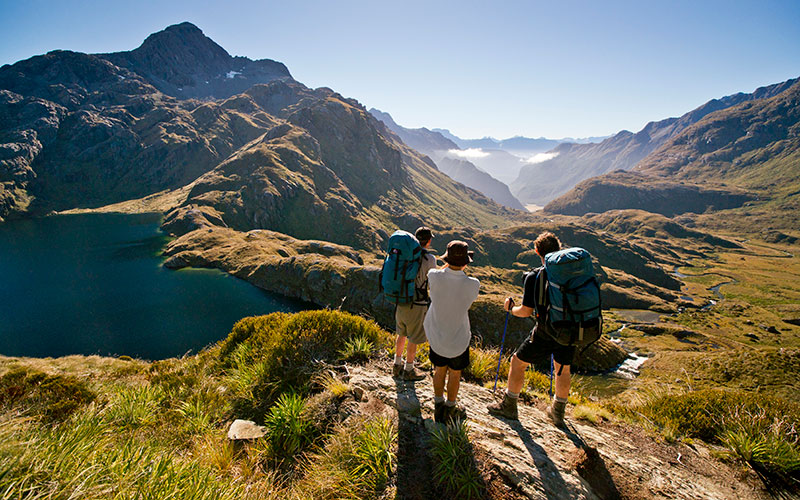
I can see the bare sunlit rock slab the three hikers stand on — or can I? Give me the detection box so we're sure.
[350,365,766,500]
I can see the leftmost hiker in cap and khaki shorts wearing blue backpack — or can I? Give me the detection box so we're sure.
[381,226,436,381]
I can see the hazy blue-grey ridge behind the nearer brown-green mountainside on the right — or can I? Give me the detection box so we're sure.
[511,80,797,205]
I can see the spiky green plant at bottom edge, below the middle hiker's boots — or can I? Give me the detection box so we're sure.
[431,421,485,500]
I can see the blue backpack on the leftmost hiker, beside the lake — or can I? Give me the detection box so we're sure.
[380,230,422,304]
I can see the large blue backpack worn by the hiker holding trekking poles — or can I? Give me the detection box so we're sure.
[536,248,603,347]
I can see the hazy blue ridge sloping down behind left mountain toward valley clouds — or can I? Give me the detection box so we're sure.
[369,108,525,210]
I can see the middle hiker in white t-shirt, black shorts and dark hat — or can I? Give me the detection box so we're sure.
[424,240,480,422]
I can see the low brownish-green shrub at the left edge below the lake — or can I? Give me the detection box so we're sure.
[0,368,95,422]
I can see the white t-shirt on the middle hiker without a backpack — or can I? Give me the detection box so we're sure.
[424,268,481,358]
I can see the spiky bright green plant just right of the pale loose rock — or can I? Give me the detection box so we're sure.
[264,393,316,461]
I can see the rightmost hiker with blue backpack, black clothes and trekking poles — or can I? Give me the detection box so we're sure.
[488,232,602,427]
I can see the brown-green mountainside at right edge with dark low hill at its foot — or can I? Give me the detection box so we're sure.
[548,79,800,230]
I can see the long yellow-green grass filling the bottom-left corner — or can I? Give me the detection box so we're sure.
[0,407,276,500]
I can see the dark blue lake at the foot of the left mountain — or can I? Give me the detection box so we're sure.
[0,214,304,359]
